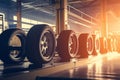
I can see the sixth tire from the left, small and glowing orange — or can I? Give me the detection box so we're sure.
[100,37,108,54]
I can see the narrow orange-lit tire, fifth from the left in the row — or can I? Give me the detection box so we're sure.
[92,35,100,55]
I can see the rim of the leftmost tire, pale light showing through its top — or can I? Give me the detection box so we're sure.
[9,34,22,60]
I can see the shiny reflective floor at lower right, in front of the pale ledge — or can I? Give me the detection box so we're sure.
[48,53,120,80]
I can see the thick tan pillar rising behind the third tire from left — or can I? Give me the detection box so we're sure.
[56,0,68,34]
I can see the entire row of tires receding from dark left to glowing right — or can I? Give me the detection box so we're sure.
[0,24,120,64]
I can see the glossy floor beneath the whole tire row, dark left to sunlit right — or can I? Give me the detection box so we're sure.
[0,52,120,80]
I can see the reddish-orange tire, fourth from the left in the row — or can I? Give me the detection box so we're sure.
[77,33,94,58]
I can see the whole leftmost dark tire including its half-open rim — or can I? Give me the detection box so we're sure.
[0,28,26,64]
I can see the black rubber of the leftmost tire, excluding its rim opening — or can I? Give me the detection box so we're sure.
[0,28,25,64]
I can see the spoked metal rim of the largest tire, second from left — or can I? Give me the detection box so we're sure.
[39,31,55,61]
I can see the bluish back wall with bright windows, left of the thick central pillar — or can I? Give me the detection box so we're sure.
[0,0,55,28]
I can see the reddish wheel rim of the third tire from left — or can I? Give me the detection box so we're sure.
[68,34,77,57]
